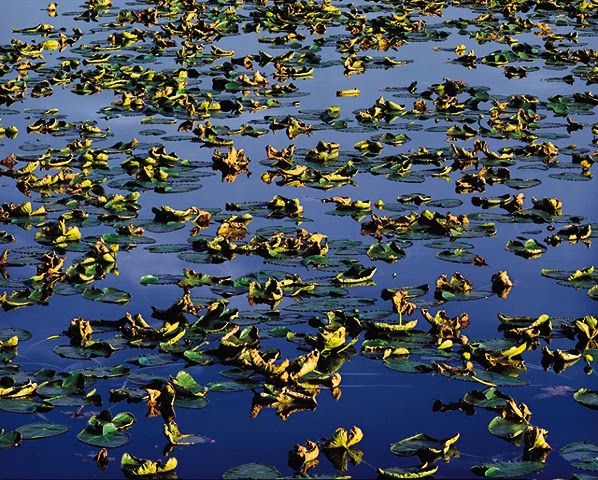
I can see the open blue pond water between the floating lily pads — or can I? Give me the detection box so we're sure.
[0,0,598,479]
